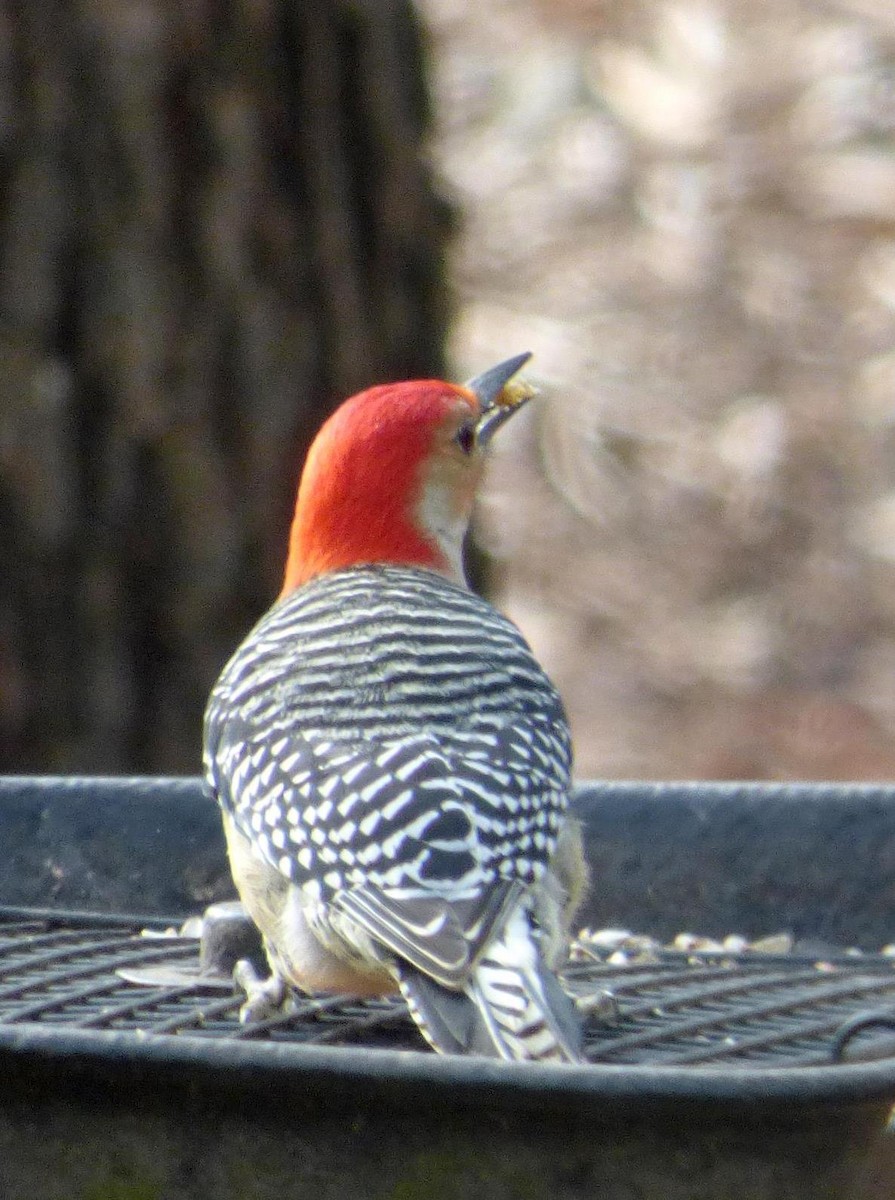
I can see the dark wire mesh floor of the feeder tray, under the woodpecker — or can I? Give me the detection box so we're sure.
[0,910,895,1070]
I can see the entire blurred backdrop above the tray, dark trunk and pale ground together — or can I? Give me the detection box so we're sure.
[0,0,895,779]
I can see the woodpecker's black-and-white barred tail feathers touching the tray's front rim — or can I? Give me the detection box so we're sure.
[398,905,582,1062]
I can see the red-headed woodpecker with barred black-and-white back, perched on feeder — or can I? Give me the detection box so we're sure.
[204,353,587,1063]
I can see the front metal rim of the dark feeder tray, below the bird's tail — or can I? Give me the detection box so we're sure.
[0,1022,895,1111]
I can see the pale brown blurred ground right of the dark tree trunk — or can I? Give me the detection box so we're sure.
[424,0,895,779]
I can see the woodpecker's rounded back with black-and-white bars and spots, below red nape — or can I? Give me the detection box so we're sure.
[205,566,571,904]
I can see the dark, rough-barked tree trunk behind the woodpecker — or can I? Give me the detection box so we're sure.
[0,0,446,772]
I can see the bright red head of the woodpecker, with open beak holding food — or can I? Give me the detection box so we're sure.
[281,354,534,595]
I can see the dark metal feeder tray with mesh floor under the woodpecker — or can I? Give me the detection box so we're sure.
[0,779,895,1200]
